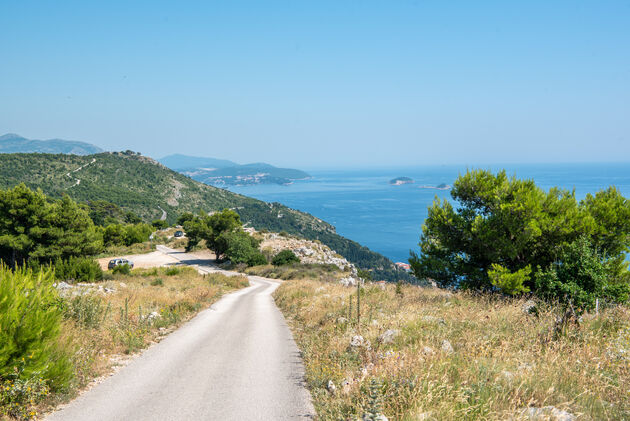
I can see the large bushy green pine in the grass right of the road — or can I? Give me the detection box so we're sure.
[409,170,630,302]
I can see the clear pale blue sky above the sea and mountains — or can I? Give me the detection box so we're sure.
[0,0,630,168]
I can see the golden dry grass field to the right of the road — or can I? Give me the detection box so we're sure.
[275,281,630,420]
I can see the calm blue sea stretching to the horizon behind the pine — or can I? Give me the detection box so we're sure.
[230,163,630,262]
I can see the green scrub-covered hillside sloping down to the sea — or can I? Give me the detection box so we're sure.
[0,152,405,281]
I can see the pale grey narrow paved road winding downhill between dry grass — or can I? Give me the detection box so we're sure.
[46,248,315,421]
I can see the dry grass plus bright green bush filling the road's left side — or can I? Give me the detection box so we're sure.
[0,266,248,419]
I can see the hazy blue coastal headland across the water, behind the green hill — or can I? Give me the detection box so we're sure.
[159,155,310,186]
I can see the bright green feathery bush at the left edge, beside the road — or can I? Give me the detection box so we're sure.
[0,265,73,389]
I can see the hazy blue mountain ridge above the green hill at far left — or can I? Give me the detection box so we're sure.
[0,133,103,155]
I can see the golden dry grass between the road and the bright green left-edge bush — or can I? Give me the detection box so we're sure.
[41,267,249,409]
